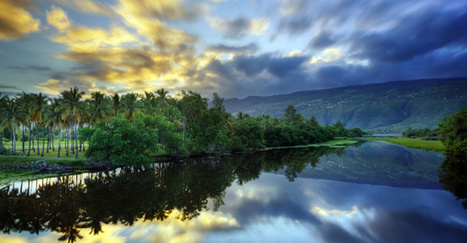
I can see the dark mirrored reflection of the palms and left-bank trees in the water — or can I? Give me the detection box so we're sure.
[0,145,348,242]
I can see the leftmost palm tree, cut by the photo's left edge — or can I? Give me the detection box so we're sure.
[0,97,28,153]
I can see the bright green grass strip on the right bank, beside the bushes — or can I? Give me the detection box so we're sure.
[364,137,445,152]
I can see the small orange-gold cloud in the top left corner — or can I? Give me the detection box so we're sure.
[0,0,41,41]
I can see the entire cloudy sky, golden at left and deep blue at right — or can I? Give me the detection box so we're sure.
[0,0,467,98]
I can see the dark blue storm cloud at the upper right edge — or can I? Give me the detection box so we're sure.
[350,10,467,62]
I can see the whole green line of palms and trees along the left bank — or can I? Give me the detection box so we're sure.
[0,87,363,164]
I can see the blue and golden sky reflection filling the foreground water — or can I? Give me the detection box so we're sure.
[0,173,467,242]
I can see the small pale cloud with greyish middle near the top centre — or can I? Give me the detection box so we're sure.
[207,17,269,39]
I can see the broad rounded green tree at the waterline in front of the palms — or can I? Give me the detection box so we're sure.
[86,116,157,166]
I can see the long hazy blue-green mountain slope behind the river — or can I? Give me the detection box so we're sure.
[224,78,467,133]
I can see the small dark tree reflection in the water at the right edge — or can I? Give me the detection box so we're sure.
[439,152,467,209]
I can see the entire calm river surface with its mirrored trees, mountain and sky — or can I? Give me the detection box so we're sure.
[0,141,467,242]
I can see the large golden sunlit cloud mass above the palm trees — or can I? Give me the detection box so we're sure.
[43,0,218,96]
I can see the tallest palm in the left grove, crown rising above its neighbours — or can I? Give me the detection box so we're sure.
[61,87,85,159]
